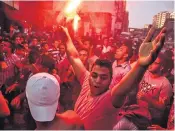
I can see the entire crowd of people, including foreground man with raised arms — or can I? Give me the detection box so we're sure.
[0,23,174,130]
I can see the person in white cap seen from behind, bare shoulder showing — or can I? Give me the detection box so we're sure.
[26,73,83,130]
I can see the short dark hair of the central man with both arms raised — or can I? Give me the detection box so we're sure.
[91,59,112,78]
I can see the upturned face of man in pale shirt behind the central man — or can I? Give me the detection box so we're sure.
[115,45,128,60]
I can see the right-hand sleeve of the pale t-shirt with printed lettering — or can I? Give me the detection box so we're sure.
[159,80,173,105]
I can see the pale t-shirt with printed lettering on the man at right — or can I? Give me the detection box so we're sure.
[138,71,172,120]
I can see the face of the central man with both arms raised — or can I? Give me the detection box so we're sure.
[89,65,111,96]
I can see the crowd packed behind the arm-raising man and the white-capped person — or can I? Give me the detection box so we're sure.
[0,25,174,130]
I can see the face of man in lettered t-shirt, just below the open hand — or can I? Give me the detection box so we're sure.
[148,57,162,74]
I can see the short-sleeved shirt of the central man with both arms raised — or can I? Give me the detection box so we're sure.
[74,71,118,130]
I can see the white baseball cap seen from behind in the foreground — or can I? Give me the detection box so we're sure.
[26,73,60,122]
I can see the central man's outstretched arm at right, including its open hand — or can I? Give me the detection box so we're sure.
[111,28,166,108]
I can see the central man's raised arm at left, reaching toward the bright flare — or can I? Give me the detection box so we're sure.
[60,27,86,79]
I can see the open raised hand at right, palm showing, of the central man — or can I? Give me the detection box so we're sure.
[138,27,166,66]
